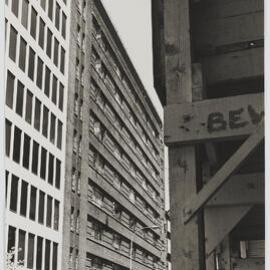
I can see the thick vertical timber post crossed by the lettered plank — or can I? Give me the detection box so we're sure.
[164,0,206,270]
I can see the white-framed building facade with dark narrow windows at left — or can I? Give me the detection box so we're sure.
[5,0,70,270]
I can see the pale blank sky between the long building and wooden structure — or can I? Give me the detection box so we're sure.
[101,0,169,210]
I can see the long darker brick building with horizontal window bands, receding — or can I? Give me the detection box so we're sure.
[62,0,166,270]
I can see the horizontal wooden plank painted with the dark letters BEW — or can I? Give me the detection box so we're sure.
[165,93,264,145]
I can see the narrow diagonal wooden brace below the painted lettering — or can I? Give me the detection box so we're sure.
[183,123,264,223]
